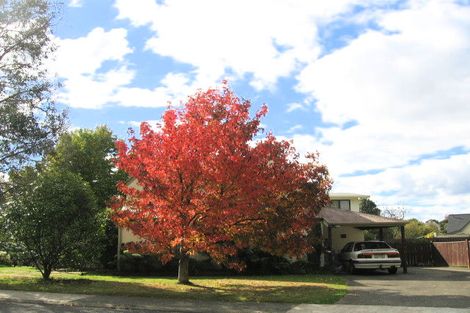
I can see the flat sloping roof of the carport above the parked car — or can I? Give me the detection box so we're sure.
[318,208,407,228]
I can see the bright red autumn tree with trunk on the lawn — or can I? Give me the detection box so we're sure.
[114,86,331,283]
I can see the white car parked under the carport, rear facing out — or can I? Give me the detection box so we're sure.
[341,241,401,274]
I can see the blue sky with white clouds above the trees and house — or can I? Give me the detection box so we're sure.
[51,0,470,220]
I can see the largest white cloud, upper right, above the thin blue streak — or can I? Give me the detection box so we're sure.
[298,2,470,174]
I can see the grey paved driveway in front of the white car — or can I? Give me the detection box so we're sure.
[338,267,470,312]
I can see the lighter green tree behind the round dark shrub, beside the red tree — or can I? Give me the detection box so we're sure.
[48,126,127,267]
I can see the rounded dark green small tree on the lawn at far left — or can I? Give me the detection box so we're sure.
[3,167,102,280]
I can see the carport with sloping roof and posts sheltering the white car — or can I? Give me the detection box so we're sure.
[318,208,408,273]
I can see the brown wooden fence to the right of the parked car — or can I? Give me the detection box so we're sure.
[390,238,470,268]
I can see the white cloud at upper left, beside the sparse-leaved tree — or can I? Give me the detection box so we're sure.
[50,28,135,109]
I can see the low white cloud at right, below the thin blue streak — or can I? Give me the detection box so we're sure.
[335,154,470,220]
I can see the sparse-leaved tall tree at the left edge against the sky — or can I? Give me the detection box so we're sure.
[0,0,65,176]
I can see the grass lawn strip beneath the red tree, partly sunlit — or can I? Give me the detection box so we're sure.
[0,266,347,304]
